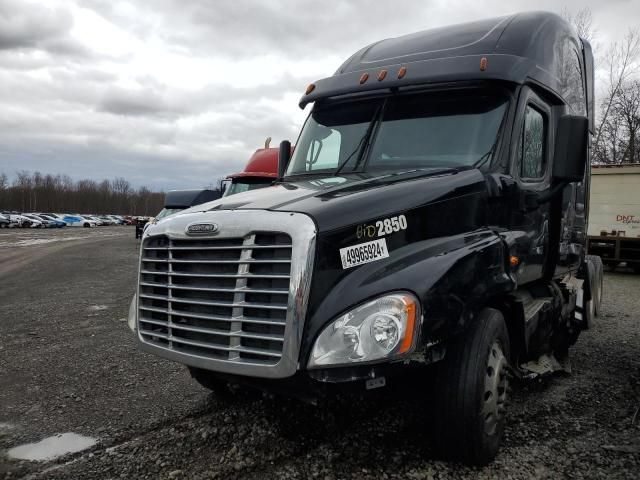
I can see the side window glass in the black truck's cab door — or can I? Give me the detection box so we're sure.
[517,105,547,181]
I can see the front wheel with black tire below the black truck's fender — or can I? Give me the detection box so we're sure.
[433,308,510,465]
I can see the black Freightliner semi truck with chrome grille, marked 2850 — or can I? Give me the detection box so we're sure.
[129,12,602,464]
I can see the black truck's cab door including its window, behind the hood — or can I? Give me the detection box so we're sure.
[510,87,553,284]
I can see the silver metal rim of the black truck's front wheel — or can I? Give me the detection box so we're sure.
[482,342,509,435]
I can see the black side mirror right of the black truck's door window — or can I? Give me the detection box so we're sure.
[553,115,589,183]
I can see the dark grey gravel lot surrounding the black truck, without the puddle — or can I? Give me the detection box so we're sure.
[0,227,640,479]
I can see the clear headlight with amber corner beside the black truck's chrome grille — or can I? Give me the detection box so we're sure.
[309,293,420,368]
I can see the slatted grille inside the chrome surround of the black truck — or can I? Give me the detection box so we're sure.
[138,232,293,366]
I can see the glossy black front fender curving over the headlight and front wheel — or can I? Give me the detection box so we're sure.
[301,229,515,364]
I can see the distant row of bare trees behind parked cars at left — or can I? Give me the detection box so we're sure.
[0,171,164,215]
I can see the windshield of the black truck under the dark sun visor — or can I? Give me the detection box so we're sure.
[287,91,507,175]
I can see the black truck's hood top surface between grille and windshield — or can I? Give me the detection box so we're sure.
[175,168,486,232]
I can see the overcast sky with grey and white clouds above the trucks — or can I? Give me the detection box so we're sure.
[0,0,640,189]
